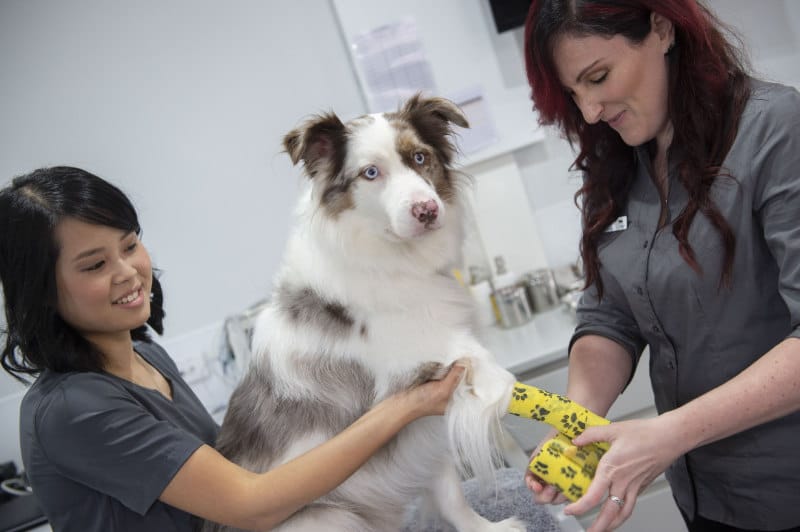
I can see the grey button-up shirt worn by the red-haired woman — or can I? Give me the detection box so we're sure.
[570,80,800,530]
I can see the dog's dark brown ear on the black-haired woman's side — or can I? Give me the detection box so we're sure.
[283,113,347,178]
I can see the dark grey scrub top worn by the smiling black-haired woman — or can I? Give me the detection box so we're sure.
[20,343,219,532]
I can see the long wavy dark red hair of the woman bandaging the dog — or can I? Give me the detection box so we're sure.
[525,0,749,296]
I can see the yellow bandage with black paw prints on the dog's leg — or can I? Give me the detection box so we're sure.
[508,382,610,502]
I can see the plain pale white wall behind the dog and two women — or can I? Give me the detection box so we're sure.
[0,0,800,472]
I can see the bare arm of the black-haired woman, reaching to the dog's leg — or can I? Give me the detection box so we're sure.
[160,366,464,530]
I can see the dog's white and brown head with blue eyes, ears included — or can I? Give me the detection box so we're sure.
[284,95,468,240]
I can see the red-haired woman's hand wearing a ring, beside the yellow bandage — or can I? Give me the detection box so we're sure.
[564,416,688,532]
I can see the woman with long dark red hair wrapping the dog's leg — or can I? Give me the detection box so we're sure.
[525,0,800,531]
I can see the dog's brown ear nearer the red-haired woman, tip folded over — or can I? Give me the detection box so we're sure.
[398,93,469,163]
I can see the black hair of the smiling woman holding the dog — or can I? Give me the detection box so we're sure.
[0,166,164,382]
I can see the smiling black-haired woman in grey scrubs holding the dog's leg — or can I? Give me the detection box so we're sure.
[0,167,463,532]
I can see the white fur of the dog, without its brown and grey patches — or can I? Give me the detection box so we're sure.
[234,105,525,532]
